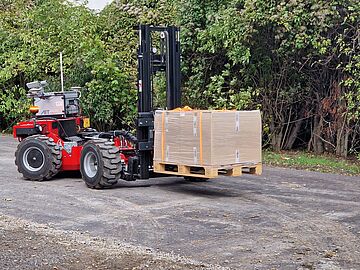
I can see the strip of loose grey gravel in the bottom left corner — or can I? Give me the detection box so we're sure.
[0,215,218,270]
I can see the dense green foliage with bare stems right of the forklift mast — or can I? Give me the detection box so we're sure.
[178,0,360,156]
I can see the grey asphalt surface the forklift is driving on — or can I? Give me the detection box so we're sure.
[0,136,360,269]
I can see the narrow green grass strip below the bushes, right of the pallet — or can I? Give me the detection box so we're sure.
[263,151,360,176]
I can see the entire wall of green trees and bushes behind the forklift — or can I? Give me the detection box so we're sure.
[0,0,360,156]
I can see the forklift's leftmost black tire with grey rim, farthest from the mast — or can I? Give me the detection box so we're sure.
[15,135,62,181]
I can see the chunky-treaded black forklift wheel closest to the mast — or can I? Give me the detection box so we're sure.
[80,140,122,189]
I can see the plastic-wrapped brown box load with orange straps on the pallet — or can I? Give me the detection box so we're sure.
[154,110,262,166]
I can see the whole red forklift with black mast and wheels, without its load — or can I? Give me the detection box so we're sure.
[13,25,181,189]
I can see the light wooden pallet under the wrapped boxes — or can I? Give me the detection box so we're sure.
[154,161,262,178]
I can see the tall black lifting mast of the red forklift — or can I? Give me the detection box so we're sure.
[135,25,181,179]
